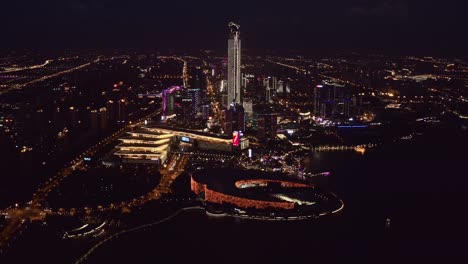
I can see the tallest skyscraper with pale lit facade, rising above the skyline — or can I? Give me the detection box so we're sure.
[227,22,242,108]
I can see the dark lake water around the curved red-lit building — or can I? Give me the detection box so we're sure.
[88,125,468,263]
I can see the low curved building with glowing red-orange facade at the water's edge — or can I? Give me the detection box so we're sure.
[191,169,343,218]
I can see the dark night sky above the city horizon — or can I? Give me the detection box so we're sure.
[0,0,468,57]
